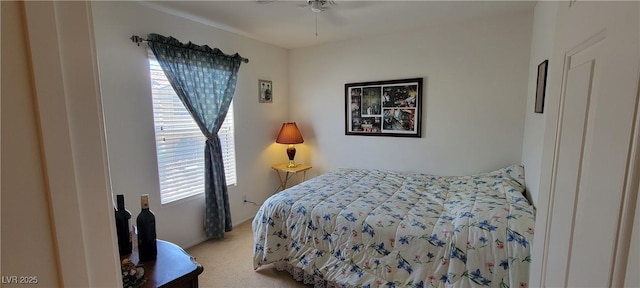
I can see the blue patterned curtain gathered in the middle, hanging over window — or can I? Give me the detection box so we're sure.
[147,34,242,239]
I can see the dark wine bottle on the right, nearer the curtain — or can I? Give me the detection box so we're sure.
[136,194,158,261]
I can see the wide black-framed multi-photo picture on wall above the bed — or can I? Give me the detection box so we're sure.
[344,78,422,137]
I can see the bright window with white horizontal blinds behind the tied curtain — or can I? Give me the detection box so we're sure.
[149,50,236,204]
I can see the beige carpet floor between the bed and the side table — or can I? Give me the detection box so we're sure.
[187,221,309,288]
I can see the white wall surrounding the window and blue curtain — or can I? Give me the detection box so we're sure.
[92,1,289,246]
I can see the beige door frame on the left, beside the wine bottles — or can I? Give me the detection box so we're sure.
[23,1,122,287]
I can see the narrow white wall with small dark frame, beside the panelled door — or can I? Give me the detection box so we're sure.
[522,1,558,206]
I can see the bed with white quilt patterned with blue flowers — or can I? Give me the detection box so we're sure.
[252,165,534,287]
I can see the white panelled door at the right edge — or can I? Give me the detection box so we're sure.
[532,1,640,287]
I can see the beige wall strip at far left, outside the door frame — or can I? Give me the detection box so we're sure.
[1,1,61,287]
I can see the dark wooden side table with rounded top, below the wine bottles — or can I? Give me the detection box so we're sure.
[128,240,204,288]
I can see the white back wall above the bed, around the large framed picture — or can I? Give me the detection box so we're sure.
[289,11,532,175]
